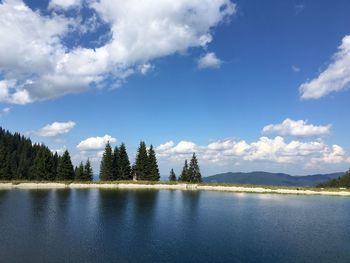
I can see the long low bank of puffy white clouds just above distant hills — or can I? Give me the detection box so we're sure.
[156,136,350,167]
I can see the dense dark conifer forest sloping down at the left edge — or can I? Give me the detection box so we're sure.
[0,128,93,181]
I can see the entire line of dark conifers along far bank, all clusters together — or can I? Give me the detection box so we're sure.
[0,127,202,183]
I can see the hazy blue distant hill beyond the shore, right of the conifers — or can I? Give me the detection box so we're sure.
[203,172,345,186]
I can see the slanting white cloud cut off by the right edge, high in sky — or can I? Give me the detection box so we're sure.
[299,35,350,99]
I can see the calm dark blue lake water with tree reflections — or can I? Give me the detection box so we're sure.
[0,190,350,262]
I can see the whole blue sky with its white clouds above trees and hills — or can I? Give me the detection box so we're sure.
[0,0,350,176]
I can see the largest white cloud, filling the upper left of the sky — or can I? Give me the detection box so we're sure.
[0,0,235,104]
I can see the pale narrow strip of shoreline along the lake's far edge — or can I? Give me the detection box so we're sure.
[0,182,350,196]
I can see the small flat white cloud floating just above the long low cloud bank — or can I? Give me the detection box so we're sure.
[262,118,331,137]
